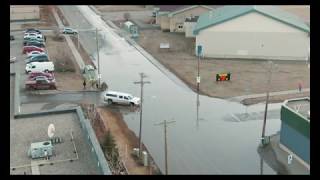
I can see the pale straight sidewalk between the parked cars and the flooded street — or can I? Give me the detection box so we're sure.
[52,6,85,69]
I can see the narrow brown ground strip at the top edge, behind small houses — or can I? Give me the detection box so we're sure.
[95,5,146,13]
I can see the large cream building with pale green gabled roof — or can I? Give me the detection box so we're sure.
[194,6,310,60]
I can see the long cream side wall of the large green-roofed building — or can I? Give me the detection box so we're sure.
[196,32,310,60]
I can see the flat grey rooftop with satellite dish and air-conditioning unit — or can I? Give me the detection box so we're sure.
[10,113,100,174]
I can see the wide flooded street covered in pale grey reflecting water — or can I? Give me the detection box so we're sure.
[62,6,281,174]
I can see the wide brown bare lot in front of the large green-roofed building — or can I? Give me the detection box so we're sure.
[137,30,310,98]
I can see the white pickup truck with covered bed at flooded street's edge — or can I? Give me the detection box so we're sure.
[103,91,140,106]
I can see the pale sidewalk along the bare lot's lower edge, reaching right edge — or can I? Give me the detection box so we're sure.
[227,88,310,102]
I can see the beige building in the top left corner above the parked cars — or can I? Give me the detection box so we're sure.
[10,5,40,21]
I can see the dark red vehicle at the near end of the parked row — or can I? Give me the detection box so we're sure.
[25,76,57,90]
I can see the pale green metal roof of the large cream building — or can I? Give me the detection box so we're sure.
[194,5,310,34]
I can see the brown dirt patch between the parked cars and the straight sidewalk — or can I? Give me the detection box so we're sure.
[46,36,83,90]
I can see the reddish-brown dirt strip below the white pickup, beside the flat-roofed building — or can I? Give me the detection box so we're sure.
[97,108,150,174]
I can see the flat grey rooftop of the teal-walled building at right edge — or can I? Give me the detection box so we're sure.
[285,98,310,121]
